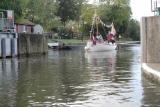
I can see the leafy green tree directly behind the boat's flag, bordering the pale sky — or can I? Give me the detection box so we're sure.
[99,0,132,34]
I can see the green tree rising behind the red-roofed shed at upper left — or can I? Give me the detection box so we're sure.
[24,0,60,31]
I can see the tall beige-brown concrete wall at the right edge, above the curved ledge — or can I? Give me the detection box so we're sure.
[141,16,160,63]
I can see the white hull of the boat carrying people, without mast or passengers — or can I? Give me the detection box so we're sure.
[84,40,117,52]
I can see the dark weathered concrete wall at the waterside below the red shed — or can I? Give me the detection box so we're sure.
[18,33,48,56]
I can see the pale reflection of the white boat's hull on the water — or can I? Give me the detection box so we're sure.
[85,50,117,72]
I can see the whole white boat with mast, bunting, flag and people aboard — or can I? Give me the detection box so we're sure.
[84,12,117,52]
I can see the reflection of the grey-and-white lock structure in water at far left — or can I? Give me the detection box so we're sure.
[0,58,18,107]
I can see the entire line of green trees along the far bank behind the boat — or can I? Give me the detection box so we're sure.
[0,0,140,40]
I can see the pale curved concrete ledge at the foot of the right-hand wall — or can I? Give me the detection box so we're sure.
[142,63,160,83]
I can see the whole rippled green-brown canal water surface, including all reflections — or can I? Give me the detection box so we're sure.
[0,44,160,107]
